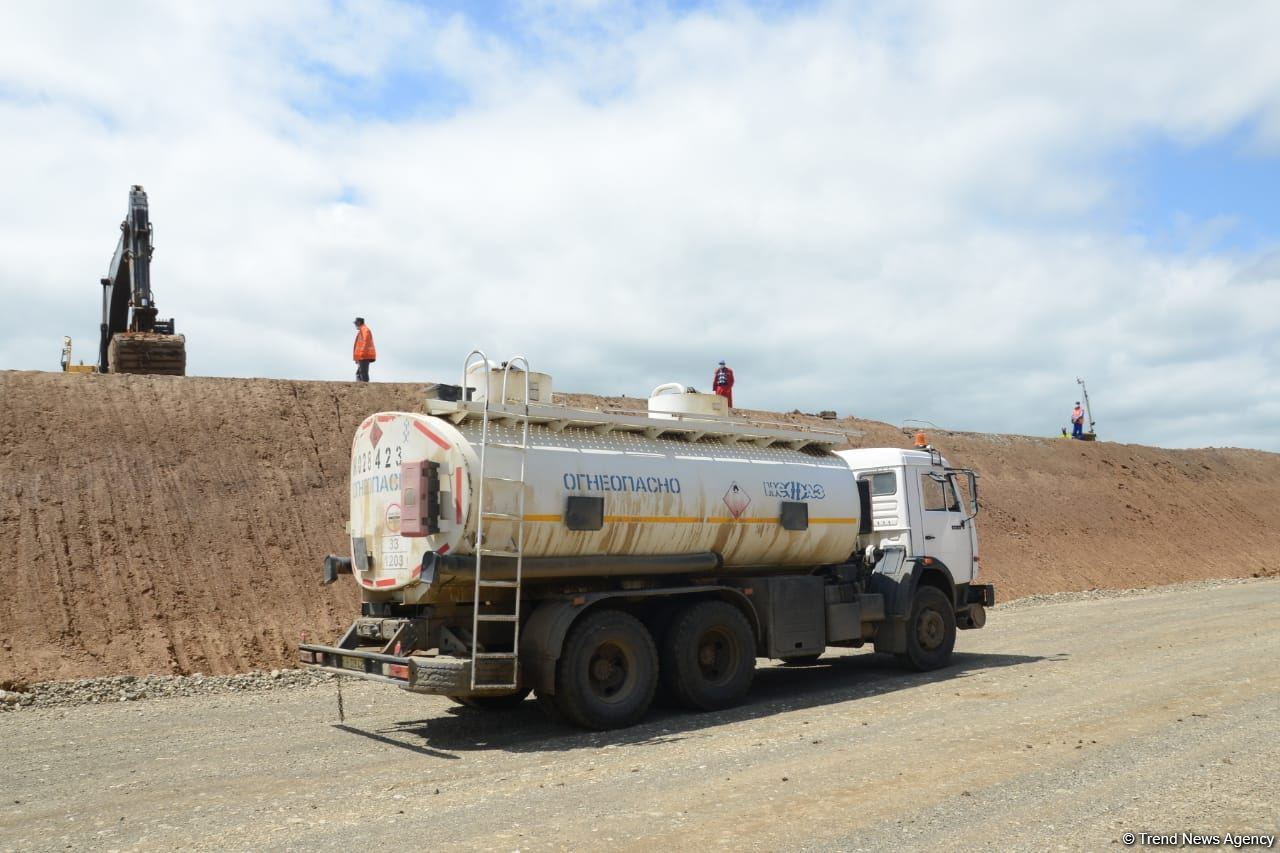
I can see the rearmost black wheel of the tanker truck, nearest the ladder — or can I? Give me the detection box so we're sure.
[556,610,658,729]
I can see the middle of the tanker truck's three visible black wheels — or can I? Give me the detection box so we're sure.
[662,601,755,711]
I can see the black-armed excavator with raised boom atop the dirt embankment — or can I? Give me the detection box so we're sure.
[92,184,187,377]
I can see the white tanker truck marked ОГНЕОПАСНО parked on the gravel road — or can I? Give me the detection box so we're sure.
[300,352,995,729]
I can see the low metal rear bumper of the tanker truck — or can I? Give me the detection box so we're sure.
[298,643,511,695]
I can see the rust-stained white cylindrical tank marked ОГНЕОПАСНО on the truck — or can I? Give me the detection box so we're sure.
[351,412,859,601]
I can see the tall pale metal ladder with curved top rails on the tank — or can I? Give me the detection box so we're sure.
[462,350,529,690]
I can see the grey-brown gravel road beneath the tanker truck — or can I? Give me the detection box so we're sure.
[0,580,1280,850]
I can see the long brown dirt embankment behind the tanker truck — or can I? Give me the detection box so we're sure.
[0,371,1280,685]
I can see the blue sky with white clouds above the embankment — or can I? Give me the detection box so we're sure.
[0,0,1280,451]
